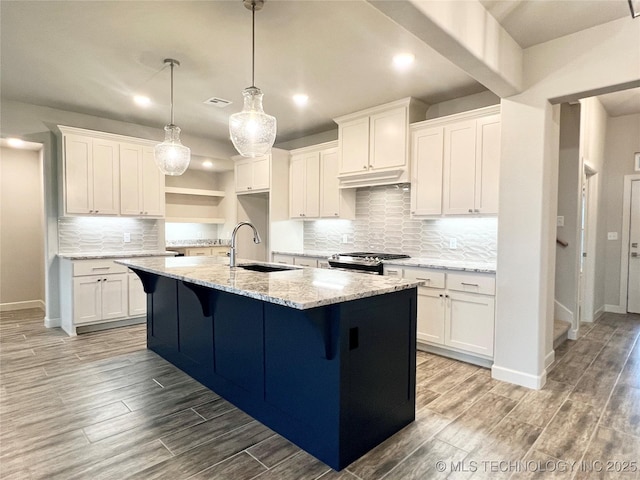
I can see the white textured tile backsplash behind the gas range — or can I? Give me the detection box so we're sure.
[304,186,498,262]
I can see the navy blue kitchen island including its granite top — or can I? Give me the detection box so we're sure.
[119,257,420,470]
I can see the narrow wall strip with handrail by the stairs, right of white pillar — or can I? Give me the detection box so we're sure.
[554,103,581,327]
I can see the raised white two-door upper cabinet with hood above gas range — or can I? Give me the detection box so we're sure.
[335,98,427,188]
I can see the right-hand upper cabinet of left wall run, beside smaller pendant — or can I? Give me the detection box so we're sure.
[120,143,165,217]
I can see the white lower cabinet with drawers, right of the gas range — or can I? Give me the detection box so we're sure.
[385,266,495,359]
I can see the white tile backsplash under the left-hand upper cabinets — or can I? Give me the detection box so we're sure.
[58,217,165,253]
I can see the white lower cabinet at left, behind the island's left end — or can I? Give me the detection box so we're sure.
[60,259,147,335]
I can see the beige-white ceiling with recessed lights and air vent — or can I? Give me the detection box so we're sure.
[0,0,640,166]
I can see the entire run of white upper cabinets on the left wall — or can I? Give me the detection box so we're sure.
[58,126,164,217]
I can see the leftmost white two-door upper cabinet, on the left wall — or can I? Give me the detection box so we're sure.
[63,131,120,215]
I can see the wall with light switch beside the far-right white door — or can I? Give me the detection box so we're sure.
[603,114,640,307]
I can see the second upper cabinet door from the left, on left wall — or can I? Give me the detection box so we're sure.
[91,139,120,215]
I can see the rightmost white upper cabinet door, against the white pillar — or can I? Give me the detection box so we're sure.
[475,115,500,213]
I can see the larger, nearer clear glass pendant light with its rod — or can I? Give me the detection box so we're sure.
[229,0,276,158]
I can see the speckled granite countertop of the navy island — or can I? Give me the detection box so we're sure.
[117,257,423,310]
